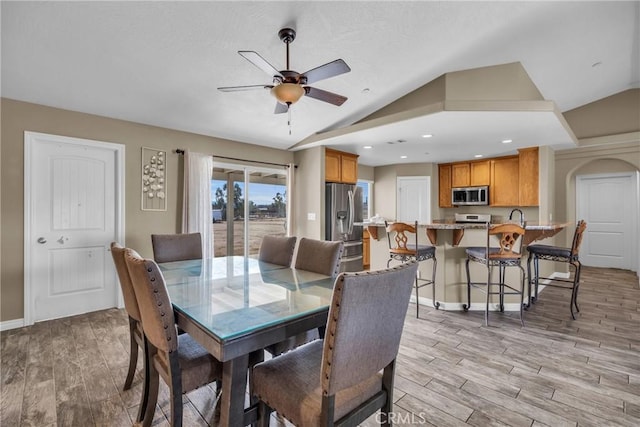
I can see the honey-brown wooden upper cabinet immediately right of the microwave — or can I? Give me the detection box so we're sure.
[489,156,520,206]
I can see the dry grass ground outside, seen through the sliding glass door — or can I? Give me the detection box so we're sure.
[213,218,286,257]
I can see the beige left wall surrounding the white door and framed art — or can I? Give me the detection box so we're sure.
[0,98,296,321]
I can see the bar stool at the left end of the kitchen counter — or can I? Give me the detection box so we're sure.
[384,221,440,317]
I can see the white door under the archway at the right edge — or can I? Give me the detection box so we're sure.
[576,172,639,271]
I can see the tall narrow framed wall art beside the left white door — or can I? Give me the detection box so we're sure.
[142,147,167,211]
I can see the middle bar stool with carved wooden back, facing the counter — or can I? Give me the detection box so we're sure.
[462,223,525,326]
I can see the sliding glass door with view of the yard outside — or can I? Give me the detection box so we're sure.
[211,162,287,257]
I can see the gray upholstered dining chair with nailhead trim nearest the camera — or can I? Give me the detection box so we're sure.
[253,261,418,426]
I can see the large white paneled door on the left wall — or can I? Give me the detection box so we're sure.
[24,132,124,325]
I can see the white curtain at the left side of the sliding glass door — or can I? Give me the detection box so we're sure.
[182,149,213,259]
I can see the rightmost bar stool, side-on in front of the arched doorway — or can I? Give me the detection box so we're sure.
[527,220,587,320]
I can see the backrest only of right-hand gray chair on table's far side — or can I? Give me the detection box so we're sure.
[295,237,344,277]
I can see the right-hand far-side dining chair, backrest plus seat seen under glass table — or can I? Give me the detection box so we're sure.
[265,237,344,356]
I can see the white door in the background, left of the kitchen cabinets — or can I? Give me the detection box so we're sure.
[396,176,431,224]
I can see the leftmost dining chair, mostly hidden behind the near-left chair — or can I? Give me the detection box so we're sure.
[111,242,144,396]
